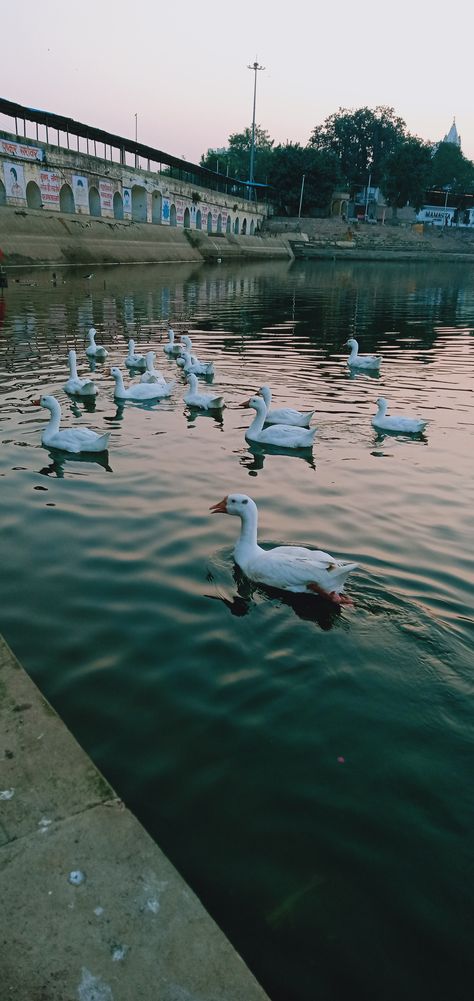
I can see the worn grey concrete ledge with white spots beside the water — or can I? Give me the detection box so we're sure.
[0,637,268,1001]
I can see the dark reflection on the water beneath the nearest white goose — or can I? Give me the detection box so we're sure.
[205,564,341,632]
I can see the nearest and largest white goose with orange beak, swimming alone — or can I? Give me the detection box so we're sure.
[210,493,357,605]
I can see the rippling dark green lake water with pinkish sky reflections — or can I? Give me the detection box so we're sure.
[0,262,474,1001]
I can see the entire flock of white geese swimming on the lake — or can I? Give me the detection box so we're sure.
[33,327,427,606]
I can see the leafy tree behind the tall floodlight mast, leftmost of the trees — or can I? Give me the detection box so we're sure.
[200,125,274,184]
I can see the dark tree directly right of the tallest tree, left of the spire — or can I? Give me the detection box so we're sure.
[380,136,432,217]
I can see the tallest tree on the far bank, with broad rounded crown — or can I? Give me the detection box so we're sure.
[309,105,406,189]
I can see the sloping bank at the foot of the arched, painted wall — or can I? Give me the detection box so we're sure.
[0,206,291,268]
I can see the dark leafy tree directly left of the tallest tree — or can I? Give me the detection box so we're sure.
[268,142,341,215]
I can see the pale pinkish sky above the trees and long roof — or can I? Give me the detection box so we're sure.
[0,0,474,162]
